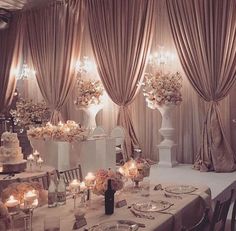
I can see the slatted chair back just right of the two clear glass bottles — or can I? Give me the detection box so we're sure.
[56,164,83,186]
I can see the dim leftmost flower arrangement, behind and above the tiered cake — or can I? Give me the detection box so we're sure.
[10,98,50,129]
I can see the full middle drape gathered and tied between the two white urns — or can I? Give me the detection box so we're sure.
[88,0,154,158]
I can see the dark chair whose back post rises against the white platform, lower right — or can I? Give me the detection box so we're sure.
[209,189,234,231]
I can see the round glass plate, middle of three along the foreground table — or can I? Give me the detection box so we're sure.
[133,200,173,212]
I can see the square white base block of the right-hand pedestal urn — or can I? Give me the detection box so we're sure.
[157,144,178,168]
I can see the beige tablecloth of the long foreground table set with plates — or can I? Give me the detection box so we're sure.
[29,184,211,231]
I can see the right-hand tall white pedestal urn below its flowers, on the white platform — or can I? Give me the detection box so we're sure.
[157,105,178,167]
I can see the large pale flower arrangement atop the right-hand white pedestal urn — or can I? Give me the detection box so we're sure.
[142,71,182,109]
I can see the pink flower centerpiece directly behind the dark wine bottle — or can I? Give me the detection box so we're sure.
[93,169,124,195]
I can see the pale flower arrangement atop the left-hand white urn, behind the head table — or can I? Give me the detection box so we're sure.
[74,78,104,107]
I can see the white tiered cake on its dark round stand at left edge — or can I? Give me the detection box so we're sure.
[0,132,26,172]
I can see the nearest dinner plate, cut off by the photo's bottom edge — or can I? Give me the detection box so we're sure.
[89,220,138,231]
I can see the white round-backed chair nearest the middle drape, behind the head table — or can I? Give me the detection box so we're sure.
[110,126,125,163]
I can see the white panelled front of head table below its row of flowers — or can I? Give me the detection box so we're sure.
[30,137,116,176]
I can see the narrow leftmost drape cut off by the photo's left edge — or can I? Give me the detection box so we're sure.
[0,14,23,113]
